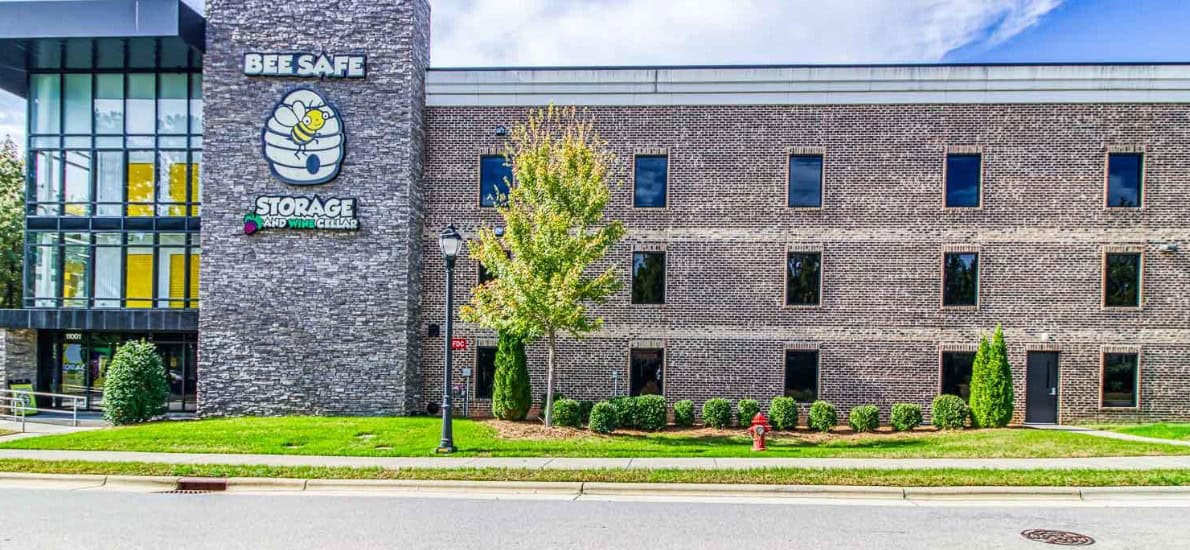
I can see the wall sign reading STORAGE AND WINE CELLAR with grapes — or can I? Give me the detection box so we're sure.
[244,195,359,235]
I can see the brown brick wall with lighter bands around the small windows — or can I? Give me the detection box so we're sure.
[418,105,1190,423]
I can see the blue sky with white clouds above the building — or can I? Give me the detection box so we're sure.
[0,0,1190,143]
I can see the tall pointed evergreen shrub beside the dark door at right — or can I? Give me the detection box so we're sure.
[970,325,1013,427]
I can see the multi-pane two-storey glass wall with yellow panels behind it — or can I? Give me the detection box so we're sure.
[25,38,202,308]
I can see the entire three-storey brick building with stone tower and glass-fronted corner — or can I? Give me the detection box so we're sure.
[0,0,1190,423]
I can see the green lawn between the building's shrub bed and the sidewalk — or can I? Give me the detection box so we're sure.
[0,417,1190,458]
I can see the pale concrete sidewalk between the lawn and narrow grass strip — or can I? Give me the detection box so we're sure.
[0,450,1190,470]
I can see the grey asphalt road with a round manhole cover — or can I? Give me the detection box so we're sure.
[0,488,1190,550]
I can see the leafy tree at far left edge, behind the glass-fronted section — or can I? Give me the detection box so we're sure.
[0,138,25,308]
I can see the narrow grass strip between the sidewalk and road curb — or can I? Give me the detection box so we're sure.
[0,460,1190,487]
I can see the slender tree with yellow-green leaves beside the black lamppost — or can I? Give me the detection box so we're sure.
[459,106,624,426]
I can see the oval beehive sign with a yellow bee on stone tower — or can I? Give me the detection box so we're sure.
[261,88,344,186]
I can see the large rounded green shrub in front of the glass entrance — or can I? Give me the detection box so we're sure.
[104,339,169,425]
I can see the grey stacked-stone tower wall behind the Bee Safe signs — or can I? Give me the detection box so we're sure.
[199,0,430,415]
